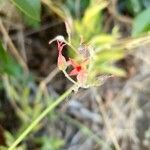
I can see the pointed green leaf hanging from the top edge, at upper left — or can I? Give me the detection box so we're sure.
[11,0,41,21]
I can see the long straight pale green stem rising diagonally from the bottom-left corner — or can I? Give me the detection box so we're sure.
[8,86,74,150]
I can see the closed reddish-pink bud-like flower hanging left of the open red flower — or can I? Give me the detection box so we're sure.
[57,40,67,70]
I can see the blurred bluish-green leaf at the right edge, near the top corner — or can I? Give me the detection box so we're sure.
[132,8,150,36]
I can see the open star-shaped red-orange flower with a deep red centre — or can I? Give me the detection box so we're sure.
[69,59,88,85]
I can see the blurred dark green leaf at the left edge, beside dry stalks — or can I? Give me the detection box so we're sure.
[0,41,22,76]
